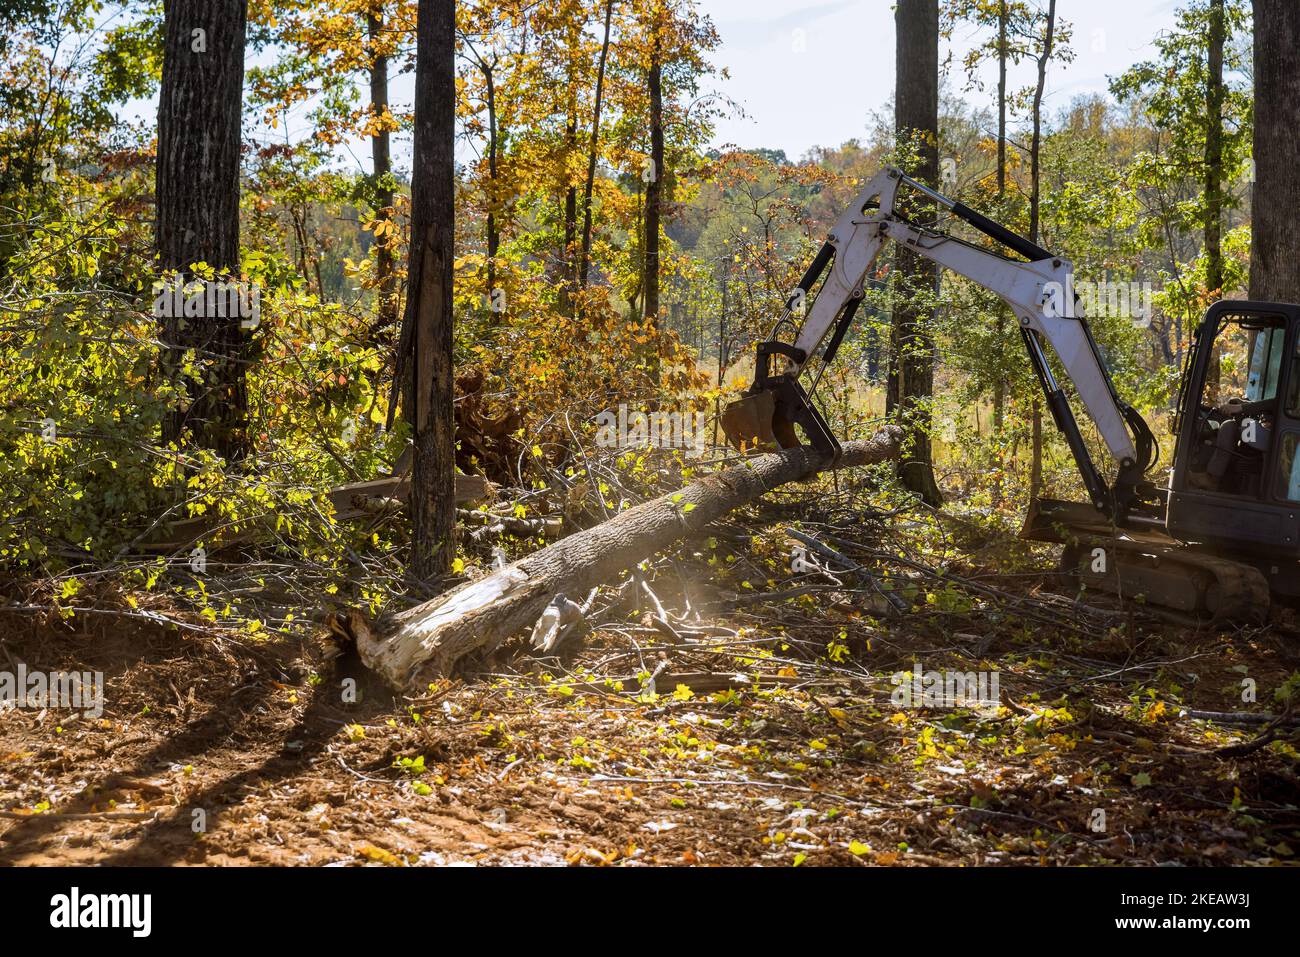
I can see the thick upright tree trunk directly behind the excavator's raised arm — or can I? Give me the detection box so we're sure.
[887,0,943,505]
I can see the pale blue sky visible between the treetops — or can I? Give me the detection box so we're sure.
[699,0,1177,159]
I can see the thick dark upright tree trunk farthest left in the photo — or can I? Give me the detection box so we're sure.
[155,0,248,460]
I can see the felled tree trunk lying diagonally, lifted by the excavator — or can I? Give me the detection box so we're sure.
[347,426,902,689]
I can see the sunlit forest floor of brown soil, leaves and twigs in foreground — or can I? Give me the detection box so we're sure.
[0,514,1300,866]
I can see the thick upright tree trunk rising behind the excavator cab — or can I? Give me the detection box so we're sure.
[1251,0,1300,303]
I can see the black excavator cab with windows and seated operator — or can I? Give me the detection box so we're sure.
[1166,300,1300,597]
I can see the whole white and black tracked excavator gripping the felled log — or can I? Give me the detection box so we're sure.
[722,168,1300,625]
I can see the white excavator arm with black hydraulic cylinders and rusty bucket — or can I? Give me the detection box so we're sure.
[723,168,1156,518]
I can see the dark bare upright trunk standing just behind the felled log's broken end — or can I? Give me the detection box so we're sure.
[403,0,456,583]
